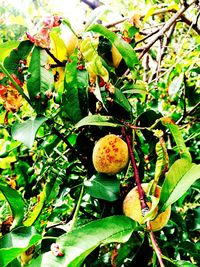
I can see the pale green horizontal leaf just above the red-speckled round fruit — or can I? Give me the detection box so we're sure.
[75,115,123,128]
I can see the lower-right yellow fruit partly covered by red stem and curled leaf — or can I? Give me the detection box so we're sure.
[123,183,171,231]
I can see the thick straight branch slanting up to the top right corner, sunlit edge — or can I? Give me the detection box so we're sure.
[138,0,196,59]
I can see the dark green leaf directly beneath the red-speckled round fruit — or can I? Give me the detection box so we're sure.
[84,174,120,201]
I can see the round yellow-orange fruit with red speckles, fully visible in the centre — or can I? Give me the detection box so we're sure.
[92,134,129,175]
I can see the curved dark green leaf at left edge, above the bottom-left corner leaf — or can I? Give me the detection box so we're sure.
[0,182,24,228]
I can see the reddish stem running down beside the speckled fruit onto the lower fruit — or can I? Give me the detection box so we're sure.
[122,128,149,216]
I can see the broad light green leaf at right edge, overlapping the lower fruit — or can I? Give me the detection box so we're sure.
[158,159,200,212]
